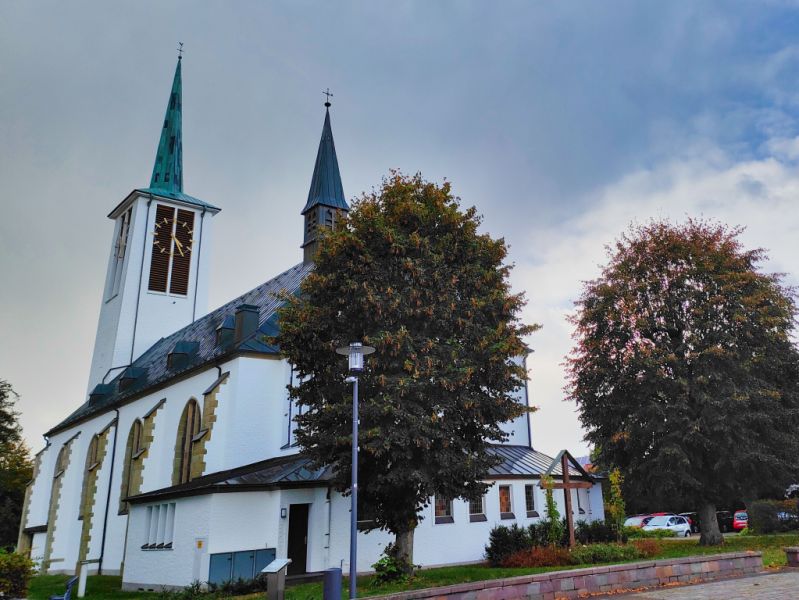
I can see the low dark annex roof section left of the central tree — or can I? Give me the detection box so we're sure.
[128,454,331,503]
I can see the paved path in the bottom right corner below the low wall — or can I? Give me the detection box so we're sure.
[625,571,799,600]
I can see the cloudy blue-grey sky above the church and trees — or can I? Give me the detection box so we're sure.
[0,0,799,454]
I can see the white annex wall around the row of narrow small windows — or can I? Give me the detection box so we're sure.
[122,496,211,590]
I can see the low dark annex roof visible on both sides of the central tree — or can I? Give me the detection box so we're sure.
[128,444,584,502]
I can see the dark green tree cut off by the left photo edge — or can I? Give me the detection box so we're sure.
[0,379,33,548]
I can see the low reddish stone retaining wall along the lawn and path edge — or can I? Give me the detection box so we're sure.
[382,552,763,600]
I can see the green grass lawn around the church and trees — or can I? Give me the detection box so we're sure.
[28,534,799,600]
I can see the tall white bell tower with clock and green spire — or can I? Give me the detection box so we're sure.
[88,57,220,392]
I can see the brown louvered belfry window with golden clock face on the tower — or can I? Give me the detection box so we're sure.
[148,204,194,296]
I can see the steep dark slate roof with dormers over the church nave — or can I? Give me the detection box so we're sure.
[46,263,313,435]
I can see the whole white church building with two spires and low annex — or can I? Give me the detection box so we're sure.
[18,60,604,589]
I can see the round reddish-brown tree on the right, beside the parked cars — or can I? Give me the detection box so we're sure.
[568,220,799,545]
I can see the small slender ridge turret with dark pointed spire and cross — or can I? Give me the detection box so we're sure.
[302,92,350,262]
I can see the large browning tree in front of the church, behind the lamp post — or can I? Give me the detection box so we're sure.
[277,173,536,563]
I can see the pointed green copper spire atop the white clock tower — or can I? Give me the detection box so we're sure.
[150,57,183,192]
